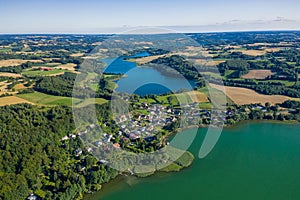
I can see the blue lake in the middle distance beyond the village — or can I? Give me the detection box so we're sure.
[104,54,196,96]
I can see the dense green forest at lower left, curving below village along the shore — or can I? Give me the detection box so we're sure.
[0,104,193,200]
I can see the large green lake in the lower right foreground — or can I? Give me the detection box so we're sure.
[88,122,300,200]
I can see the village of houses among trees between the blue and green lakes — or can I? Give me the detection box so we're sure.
[61,99,287,157]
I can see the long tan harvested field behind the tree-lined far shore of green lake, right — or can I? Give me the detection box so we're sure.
[210,84,293,105]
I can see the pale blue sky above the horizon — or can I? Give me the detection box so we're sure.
[0,0,300,33]
